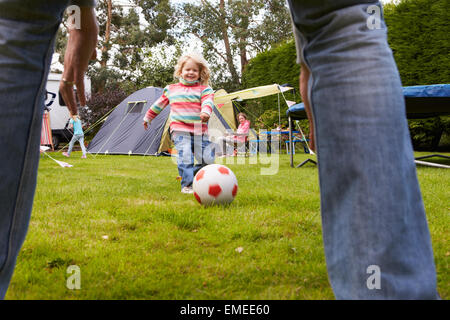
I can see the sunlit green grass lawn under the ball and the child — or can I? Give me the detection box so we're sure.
[6,152,450,300]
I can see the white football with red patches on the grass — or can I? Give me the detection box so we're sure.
[192,164,238,206]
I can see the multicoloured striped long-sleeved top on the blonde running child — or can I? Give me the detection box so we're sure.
[144,79,214,134]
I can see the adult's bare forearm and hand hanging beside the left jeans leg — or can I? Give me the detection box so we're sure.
[59,7,98,115]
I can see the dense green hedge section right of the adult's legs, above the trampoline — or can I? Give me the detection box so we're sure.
[384,0,450,86]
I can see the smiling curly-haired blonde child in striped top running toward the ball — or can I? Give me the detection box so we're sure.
[143,54,214,193]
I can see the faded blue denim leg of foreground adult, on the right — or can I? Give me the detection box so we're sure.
[288,0,438,299]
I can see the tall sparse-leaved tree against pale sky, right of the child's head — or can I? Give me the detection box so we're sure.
[177,0,292,90]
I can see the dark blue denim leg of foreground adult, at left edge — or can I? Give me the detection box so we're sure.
[0,0,68,298]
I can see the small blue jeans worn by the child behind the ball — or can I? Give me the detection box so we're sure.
[172,132,215,188]
